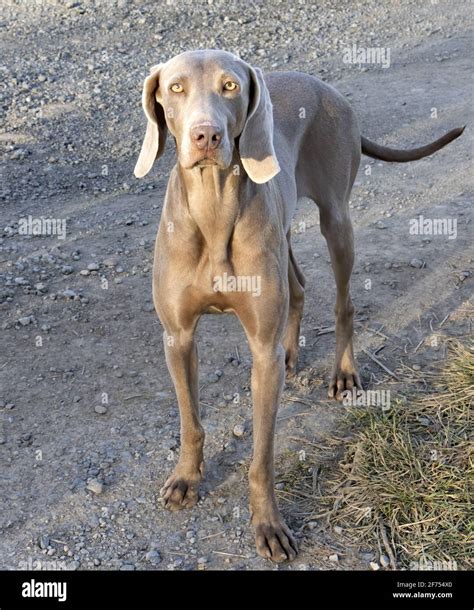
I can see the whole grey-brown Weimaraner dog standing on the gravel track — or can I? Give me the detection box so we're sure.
[135,50,462,562]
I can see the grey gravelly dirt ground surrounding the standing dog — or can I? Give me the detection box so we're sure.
[0,0,474,570]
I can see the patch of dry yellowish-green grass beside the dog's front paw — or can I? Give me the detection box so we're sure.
[281,341,474,568]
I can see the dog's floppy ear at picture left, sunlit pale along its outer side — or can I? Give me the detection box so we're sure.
[133,64,167,178]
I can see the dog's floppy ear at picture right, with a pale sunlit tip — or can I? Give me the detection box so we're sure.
[239,66,280,184]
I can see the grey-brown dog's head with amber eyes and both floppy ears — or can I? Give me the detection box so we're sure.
[135,51,280,183]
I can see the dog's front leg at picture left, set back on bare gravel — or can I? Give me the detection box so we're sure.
[161,328,204,510]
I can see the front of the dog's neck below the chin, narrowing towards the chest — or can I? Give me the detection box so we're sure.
[178,152,249,278]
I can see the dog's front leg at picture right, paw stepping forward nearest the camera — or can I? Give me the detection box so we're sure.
[249,341,297,562]
